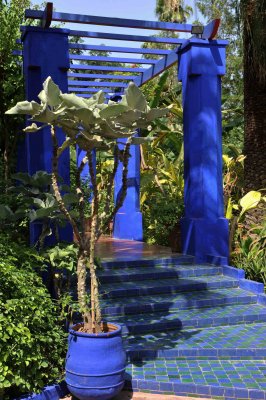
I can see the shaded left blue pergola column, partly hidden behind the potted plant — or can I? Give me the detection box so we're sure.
[22,27,73,244]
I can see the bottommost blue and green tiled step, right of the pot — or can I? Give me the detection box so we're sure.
[126,359,266,400]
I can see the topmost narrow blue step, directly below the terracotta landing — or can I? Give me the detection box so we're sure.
[101,254,194,269]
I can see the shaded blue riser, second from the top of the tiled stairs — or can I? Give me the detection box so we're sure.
[100,267,222,284]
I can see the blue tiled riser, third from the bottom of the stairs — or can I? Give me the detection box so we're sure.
[118,314,266,336]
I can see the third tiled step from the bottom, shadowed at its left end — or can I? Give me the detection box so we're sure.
[106,304,266,335]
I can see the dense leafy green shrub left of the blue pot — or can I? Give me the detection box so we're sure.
[0,235,66,399]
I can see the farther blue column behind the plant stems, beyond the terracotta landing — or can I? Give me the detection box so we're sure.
[113,134,143,241]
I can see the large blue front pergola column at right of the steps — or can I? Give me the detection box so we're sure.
[178,39,229,262]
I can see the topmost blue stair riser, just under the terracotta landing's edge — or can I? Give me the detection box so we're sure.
[102,257,194,269]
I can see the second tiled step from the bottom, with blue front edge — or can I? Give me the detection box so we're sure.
[124,323,266,361]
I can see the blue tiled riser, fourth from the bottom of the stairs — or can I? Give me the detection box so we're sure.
[102,296,257,316]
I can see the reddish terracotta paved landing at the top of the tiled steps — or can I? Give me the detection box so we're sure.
[96,236,176,260]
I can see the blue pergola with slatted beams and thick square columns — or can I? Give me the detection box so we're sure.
[15,3,228,262]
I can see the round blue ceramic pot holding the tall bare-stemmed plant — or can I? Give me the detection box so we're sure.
[66,324,126,400]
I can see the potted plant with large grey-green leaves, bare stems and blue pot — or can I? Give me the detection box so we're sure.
[6,77,168,400]
